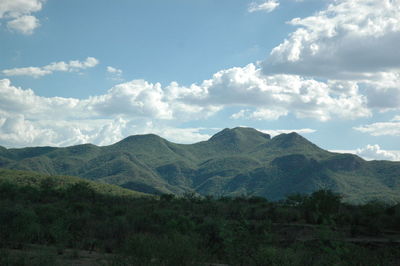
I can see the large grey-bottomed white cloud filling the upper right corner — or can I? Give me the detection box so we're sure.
[264,0,400,80]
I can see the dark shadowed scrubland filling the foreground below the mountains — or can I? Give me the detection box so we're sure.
[0,171,400,265]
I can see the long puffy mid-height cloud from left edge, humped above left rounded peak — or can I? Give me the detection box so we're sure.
[0,76,219,123]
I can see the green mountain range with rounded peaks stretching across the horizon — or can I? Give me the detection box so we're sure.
[0,127,400,203]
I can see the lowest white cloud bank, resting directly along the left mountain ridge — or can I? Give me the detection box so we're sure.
[0,115,211,147]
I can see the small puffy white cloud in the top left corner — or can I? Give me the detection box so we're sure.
[0,0,45,35]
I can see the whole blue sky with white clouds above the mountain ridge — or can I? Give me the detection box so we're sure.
[0,0,400,161]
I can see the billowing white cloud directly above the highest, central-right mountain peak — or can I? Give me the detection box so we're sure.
[188,64,370,121]
